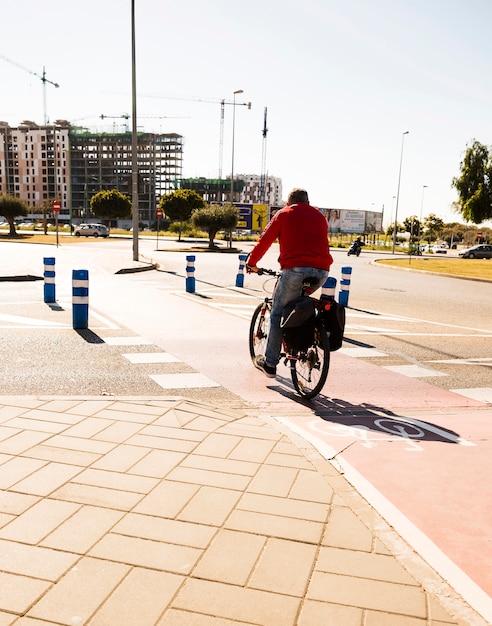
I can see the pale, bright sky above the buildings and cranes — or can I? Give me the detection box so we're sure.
[0,0,492,225]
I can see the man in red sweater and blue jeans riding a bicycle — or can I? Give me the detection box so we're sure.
[246,189,333,378]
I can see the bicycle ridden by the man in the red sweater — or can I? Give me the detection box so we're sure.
[249,268,333,398]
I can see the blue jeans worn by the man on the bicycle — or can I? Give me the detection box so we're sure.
[265,267,329,367]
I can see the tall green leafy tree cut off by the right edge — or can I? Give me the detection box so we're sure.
[452,140,492,224]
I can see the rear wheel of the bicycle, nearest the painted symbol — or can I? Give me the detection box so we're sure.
[290,319,330,398]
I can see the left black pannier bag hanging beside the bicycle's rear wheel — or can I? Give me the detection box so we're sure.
[280,296,316,353]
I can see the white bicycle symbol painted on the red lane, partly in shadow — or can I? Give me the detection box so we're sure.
[310,416,475,452]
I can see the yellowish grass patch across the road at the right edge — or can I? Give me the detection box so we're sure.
[376,257,492,281]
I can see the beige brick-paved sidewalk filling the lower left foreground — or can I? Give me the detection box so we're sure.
[0,396,486,626]
